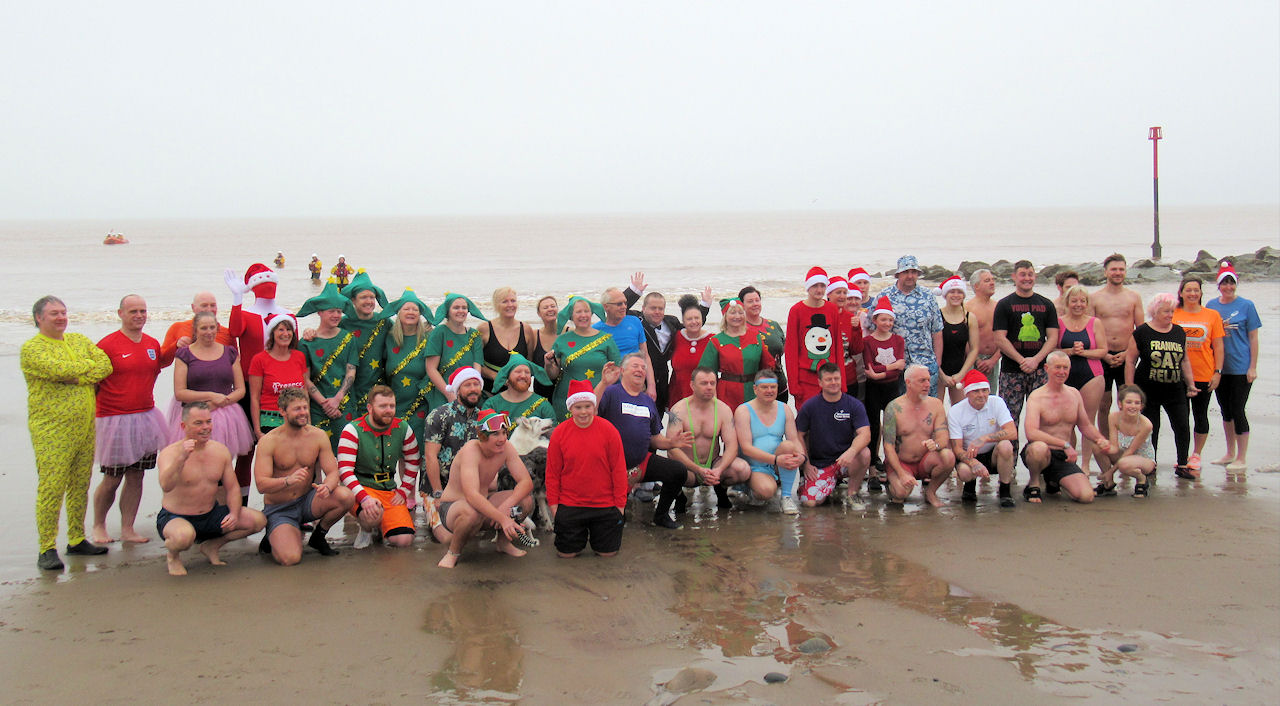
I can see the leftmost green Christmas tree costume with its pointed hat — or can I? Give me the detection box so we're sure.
[298,279,358,454]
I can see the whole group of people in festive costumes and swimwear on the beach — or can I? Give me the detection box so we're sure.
[20,255,1261,574]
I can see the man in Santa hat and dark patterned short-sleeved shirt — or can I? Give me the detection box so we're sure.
[419,366,484,498]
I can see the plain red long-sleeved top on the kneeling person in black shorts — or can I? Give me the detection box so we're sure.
[547,417,628,508]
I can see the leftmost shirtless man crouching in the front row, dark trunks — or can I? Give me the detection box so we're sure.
[156,402,266,576]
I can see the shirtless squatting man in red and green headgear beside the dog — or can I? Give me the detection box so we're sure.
[436,409,534,569]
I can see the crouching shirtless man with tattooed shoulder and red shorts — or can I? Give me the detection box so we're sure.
[883,366,956,508]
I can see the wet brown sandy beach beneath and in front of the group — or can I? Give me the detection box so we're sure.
[0,272,1280,703]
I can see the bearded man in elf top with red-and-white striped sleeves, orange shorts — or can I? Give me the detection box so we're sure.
[338,385,422,549]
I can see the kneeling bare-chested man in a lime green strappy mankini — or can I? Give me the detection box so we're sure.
[667,366,751,510]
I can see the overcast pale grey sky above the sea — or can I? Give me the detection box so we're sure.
[0,0,1280,219]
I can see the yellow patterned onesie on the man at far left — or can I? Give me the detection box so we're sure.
[19,334,111,553]
